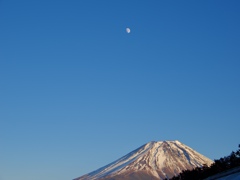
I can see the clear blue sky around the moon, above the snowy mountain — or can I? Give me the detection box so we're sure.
[0,0,240,180]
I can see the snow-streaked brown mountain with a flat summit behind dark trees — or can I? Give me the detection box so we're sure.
[74,141,213,180]
